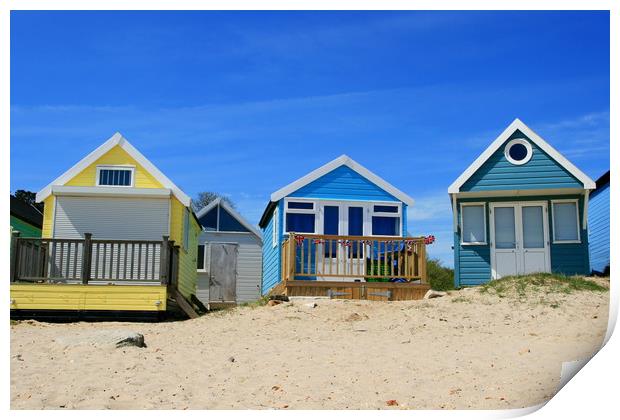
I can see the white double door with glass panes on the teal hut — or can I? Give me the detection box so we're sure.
[490,202,551,279]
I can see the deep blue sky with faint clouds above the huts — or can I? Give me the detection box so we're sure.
[11,11,609,265]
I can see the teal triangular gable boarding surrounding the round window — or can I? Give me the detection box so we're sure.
[460,130,583,192]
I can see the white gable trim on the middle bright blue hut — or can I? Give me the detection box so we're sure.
[271,155,414,206]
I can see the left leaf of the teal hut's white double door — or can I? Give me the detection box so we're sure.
[491,205,519,278]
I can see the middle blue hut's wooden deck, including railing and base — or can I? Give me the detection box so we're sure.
[272,233,430,301]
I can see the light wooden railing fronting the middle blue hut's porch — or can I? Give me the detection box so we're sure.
[282,233,427,283]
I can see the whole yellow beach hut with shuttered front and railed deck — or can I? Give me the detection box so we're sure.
[11,133,201,318]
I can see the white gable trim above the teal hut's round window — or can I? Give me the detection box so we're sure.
[448,118,596,194]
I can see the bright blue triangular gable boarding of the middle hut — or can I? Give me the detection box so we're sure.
[289,165,400,202]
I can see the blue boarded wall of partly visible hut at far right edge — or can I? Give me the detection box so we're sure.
[588,184,610,273]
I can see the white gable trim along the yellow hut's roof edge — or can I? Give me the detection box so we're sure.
[36,132,191,207]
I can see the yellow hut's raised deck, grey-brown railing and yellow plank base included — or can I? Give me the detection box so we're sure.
[10,234,186,316]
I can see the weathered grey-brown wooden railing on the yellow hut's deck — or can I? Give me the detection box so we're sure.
[11,233,177,284]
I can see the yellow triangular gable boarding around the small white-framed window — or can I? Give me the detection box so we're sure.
[65,146,163,188]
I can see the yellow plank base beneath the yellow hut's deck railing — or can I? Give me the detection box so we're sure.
[10,284,166,311]
